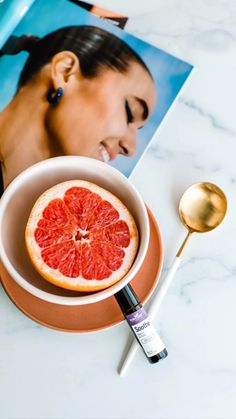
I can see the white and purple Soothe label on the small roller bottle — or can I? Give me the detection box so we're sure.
[125,307,165,357]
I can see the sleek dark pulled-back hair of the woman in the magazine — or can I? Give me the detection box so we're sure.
[2,26,152,88]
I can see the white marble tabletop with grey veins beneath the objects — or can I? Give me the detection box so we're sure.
[0,0,236,419]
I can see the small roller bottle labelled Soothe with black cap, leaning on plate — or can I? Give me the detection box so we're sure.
[115,285,168,364]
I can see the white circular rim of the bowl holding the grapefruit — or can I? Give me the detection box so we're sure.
[0,156,150,306]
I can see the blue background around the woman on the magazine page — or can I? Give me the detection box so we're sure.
[0,0,193,176]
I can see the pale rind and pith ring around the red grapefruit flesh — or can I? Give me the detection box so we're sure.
[25,180,139,292]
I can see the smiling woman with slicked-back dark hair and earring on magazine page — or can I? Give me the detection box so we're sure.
[0,26,156,192]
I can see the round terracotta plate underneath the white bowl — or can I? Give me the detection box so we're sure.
[0,209,163,333]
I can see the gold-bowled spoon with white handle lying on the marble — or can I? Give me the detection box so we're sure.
[119,182,227,375]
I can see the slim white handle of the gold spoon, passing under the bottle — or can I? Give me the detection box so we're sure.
[119,256,181,376]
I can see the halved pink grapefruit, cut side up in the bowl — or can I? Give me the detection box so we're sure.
[25,180,139,292]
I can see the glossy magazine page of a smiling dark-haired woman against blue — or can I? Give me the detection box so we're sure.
[0,0,193,192]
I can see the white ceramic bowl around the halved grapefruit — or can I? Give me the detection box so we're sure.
[0,156,149,305]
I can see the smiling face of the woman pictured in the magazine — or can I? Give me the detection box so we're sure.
[45,62,156,162]
